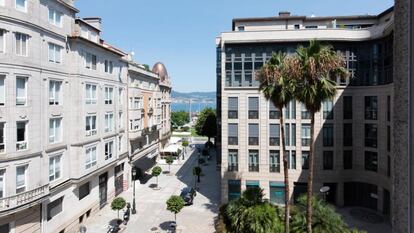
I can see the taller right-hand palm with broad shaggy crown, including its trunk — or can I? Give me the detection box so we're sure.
[287,40,347,233]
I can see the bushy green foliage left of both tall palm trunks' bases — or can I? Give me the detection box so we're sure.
[225,188,283,233]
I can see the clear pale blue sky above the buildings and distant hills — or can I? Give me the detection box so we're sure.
[75,0,394,92]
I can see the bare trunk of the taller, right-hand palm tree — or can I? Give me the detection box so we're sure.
[306,112,315,233]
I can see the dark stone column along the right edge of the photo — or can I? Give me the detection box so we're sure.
[392,0,414,233]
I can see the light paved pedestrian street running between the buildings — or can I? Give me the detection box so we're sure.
[86,144,220,233]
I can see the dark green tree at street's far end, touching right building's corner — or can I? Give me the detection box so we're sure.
[194,108,217,141]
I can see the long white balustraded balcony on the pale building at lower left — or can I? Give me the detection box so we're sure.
[0,184,49,213]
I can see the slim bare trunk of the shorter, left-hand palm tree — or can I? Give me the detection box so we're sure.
[279,107,290,233]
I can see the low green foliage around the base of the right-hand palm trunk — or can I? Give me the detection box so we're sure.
[291,195,352,233]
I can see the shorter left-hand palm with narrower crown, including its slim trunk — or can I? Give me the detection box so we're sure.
[256,52,295,233]
